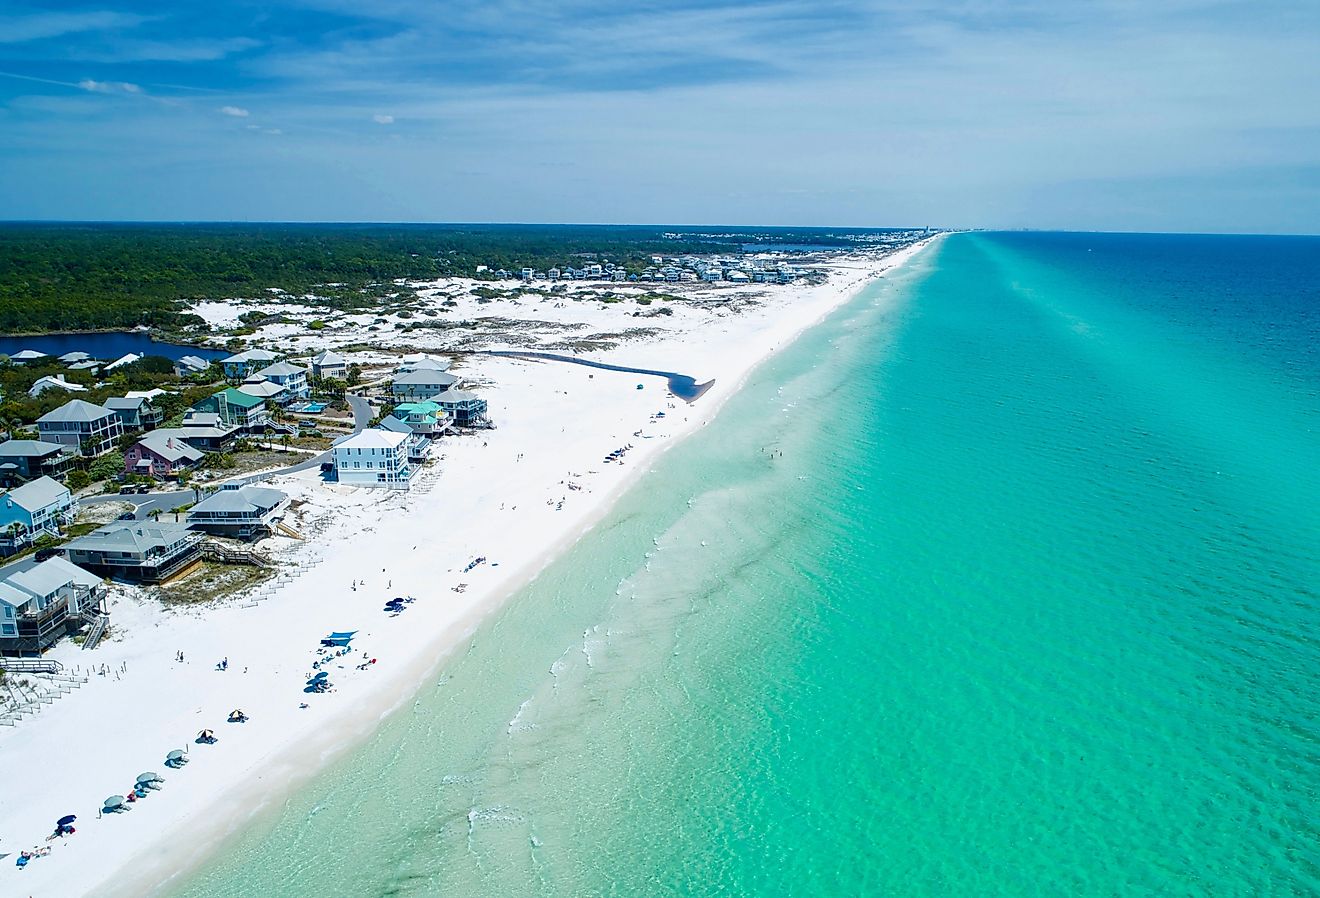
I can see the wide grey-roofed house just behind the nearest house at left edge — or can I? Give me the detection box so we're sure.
[65,520,203,582]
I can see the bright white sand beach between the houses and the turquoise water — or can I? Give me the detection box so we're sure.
[0,244,924,898]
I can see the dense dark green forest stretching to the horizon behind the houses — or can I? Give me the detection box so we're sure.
[0,223,908,334]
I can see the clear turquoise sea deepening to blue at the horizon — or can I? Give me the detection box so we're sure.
[173,235,1320,898]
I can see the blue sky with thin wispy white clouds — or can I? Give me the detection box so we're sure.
[0,0,1320,234]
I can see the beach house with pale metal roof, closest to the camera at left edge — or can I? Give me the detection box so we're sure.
[0,556,110,658]
